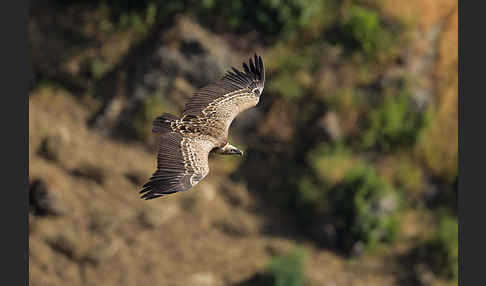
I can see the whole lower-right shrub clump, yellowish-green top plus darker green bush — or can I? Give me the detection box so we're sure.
[294,144,401,252]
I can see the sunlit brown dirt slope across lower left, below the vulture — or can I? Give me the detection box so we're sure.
[29,87,406,285]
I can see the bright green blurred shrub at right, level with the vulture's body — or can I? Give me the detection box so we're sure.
[363,92,424,151]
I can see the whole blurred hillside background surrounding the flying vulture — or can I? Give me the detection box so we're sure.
[29,0,458,286]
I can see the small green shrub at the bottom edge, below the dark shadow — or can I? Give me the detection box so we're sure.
[267,250,306,286]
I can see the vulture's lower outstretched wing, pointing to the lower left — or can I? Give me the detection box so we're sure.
[140,132,215,200]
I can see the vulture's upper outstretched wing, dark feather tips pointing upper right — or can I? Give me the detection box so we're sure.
[183,54,265,132]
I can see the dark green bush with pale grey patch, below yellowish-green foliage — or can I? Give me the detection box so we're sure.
[329,167,399,250]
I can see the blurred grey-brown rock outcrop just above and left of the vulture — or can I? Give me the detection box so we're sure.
[87,17,245,140]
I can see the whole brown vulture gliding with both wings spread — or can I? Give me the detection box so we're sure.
[140,54,265,200]
